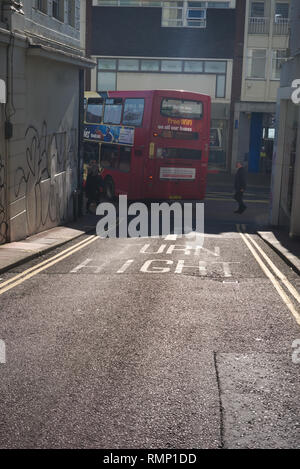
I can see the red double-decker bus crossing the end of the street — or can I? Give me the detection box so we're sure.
[84,90,210,200]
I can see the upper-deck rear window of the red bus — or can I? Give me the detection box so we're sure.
[160,98,203,119]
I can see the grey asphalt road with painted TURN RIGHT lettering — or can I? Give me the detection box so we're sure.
[0,194,300,449]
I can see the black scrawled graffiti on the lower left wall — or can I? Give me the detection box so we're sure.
[14,121,77,235]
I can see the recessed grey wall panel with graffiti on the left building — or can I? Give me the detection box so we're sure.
[8,48,79,241]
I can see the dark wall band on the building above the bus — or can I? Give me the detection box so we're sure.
[90,7,236,59]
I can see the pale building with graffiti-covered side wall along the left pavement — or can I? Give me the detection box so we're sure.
[0,0,93,243]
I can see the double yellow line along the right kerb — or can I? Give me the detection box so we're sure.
[236,225,300,326]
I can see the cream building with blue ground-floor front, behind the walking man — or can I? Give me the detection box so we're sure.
[231,0,290,173]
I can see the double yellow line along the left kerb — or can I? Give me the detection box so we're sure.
[0,235,99,295]
